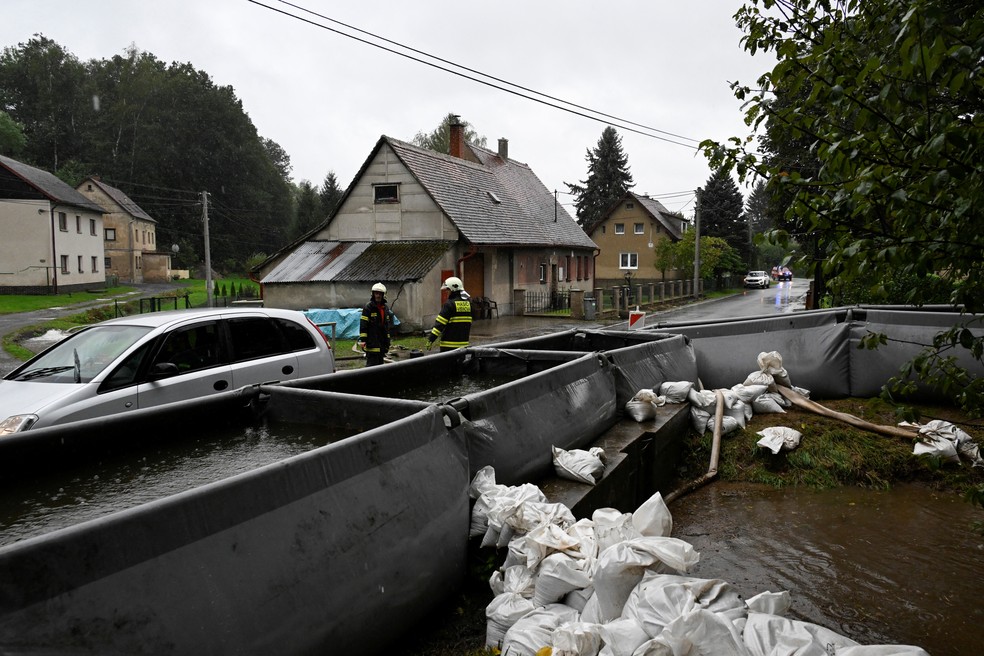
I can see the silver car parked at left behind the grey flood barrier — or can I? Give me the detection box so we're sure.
[0,308,335,439]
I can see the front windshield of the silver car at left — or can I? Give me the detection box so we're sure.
[10,326,152,383]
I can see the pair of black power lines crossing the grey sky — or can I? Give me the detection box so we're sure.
[249,0,698,150]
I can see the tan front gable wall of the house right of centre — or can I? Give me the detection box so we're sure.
[591,200,679,284]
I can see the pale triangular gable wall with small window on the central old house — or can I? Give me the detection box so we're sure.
[322,144,459,241]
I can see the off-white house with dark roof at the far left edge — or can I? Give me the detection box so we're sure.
[0,156,106,294]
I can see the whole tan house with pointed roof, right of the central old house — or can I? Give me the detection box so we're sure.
[584,191,687,287]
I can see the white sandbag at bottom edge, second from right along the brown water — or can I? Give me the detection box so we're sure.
[742,613,858,656]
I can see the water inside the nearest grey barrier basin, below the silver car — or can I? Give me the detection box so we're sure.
[0,424,351,546]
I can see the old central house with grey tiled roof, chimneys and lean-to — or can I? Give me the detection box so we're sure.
[253,125,597,330]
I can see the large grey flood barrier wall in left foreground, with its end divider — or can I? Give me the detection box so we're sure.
[0,386,471,654]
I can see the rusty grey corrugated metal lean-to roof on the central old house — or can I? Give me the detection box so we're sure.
[260,241,454,284]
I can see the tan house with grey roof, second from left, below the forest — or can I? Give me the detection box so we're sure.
[76,176,171,283]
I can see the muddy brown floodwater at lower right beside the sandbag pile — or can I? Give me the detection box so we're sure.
[670,483,984,656]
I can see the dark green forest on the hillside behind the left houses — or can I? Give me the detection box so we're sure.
[0,35,320,273]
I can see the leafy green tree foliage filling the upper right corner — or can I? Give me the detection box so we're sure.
[703,0,984,411]
